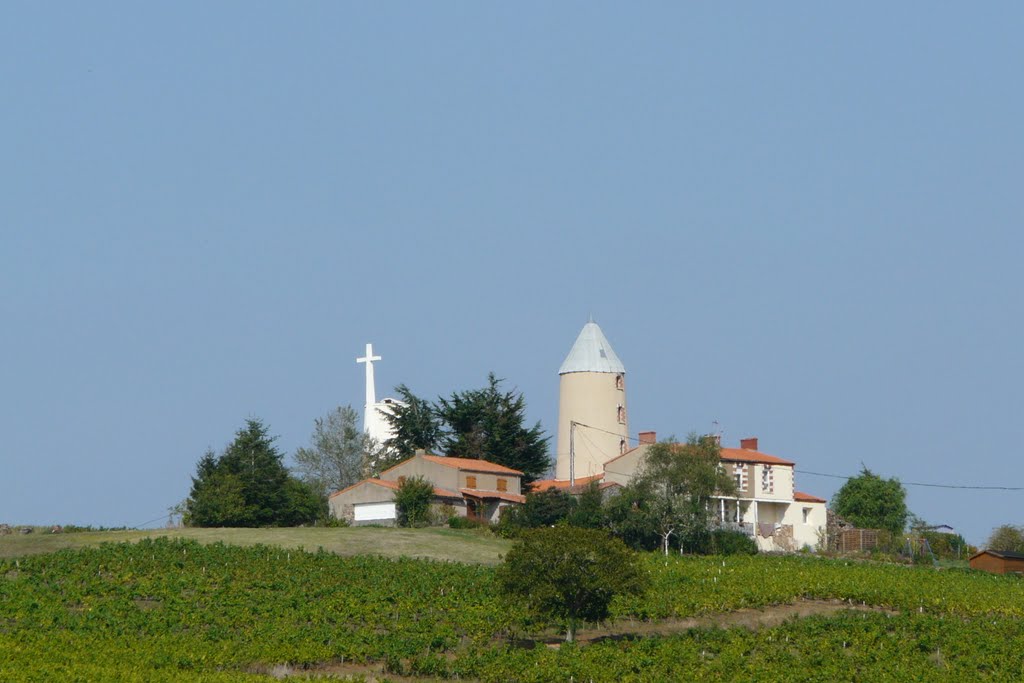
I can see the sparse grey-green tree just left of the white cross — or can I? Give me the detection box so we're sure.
[295,405,378,498]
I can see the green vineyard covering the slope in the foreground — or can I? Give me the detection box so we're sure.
[0,539,1024,681]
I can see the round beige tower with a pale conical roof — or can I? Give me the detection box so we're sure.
[555,319,630,480]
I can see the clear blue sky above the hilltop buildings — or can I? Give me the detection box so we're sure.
[0,1,1024,543]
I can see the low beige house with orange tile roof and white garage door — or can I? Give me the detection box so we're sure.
[328,453,525,524]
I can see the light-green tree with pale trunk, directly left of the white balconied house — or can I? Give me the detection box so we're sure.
[634,434,736,554]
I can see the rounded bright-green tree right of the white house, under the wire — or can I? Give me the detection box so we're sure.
[831,466,909,536]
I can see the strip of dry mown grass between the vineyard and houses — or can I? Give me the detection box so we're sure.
[0,526,509,564]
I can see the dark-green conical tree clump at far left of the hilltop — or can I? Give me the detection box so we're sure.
[184,418,326,526]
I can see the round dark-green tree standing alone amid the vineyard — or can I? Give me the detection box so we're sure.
[497,526,647,642]
